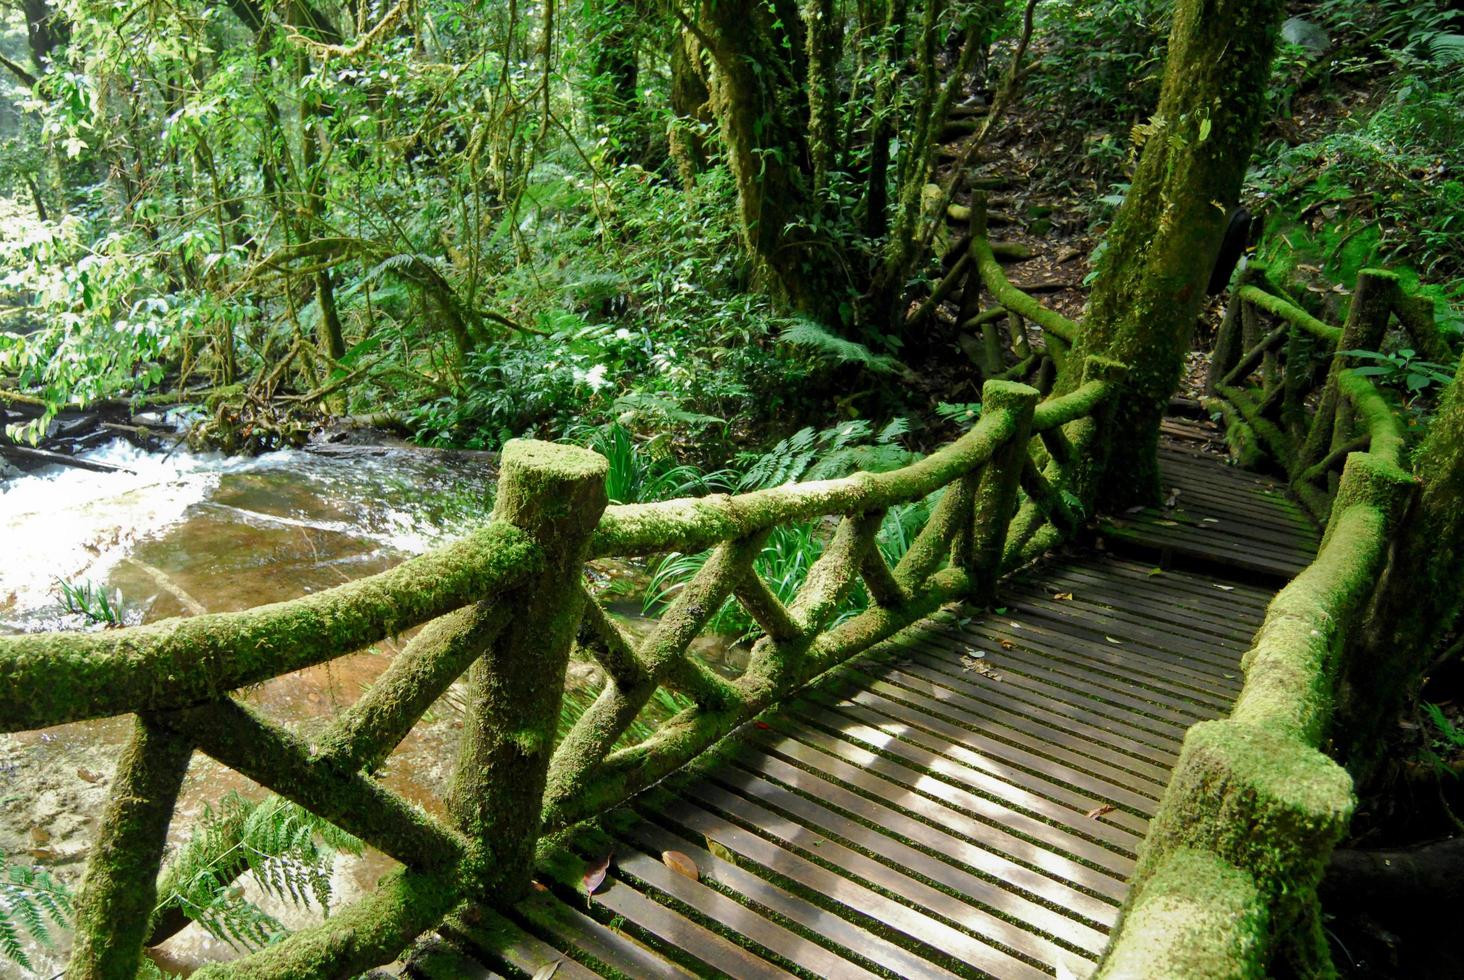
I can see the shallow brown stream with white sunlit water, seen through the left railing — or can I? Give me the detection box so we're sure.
[0,439,745,977]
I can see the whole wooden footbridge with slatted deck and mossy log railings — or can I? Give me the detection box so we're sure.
[0,250,1423,980]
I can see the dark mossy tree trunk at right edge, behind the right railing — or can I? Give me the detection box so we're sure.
[1337,347,1464,781]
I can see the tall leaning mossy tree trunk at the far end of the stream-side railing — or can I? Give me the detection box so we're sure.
[1058,0,1285,507]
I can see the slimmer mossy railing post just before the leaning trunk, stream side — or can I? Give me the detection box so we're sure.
[966,381,1042,602]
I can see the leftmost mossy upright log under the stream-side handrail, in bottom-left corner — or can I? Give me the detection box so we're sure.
[66,716,193,980]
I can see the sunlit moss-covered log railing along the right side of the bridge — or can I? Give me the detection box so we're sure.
[1095,267,1442,980]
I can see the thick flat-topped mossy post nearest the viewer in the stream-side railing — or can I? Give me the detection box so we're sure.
[449,439,608,904]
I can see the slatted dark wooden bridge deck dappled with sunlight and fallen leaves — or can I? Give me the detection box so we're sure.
[408,448,1315,980]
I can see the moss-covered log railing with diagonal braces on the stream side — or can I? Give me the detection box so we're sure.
[0,359,1123,980]
